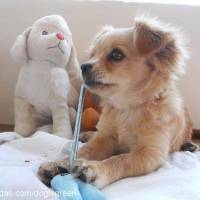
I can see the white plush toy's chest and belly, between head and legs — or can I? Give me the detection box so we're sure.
[15,61,70,116]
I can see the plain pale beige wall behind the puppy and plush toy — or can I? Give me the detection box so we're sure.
[0,0,200,127]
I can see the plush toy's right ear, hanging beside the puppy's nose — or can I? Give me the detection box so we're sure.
[66,43,82,91]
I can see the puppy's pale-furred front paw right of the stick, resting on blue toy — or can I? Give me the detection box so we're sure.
[72,159,109,188]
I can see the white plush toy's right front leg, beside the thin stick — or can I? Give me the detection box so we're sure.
[52,102,72,139]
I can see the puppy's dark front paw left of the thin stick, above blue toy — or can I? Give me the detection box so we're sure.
[38,159,68,186]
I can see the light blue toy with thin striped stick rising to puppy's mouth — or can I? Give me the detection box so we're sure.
[51,85,106,200]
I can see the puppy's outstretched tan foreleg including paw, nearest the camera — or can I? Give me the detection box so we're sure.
[73,143,167,188]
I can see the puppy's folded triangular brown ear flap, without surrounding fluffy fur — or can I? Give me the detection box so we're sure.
[134,22,167,55]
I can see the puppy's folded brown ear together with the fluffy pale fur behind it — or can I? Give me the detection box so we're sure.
[133,18,188,76]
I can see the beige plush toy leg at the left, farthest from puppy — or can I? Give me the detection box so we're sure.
[14,97,37,137]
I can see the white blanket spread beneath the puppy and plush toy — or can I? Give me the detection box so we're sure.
[0,132,200,200]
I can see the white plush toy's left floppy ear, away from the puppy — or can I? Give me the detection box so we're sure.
[11,27,32,64]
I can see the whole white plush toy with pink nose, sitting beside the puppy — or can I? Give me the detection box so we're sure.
[11,15,81,138]
